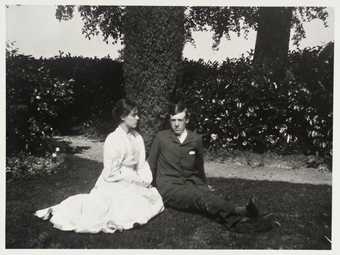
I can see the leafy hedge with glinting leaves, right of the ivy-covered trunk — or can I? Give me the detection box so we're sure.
[182,47,333,156]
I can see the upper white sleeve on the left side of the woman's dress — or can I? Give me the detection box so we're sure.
[102,135,124,182]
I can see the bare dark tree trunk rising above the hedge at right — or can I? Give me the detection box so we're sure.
[254,7,292,74]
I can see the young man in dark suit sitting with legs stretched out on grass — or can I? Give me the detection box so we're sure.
[148,102,274,232]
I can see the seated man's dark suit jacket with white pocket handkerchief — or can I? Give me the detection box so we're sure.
[148,130,206,193]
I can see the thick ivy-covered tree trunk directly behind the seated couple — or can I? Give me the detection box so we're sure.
[123,6,184,149]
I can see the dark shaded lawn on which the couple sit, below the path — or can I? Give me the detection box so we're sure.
[6,156,331,249]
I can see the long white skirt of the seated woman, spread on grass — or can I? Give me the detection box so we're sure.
[35,182,164,233]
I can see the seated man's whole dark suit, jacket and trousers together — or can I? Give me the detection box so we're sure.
[148,130,239,226]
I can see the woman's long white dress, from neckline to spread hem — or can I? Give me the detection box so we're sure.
[35,127,164,233]
